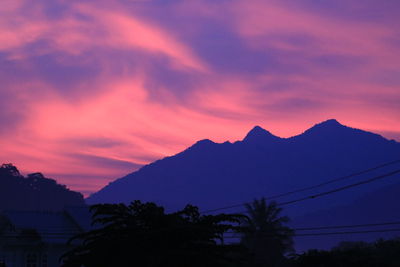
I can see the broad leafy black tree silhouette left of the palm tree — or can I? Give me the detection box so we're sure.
[62,201,248,267]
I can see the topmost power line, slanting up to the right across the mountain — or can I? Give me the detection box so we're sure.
[201,160,400,214]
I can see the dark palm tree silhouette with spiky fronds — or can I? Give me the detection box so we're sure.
[241,198,294,267]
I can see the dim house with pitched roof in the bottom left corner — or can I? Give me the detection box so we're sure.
[0,207,90,267]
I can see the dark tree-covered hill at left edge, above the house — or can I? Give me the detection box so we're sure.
[0,164,85,211]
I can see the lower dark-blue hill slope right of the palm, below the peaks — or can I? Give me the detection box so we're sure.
[291,182,400,251]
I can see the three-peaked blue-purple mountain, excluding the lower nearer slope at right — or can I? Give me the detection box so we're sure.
[86,120,400,216]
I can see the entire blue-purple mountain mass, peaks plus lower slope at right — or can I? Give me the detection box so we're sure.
[86,120,400,251]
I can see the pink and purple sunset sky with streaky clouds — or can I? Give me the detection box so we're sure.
[0,0,400,195]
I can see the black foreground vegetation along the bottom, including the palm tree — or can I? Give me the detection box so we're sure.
[62,199,400,267]
